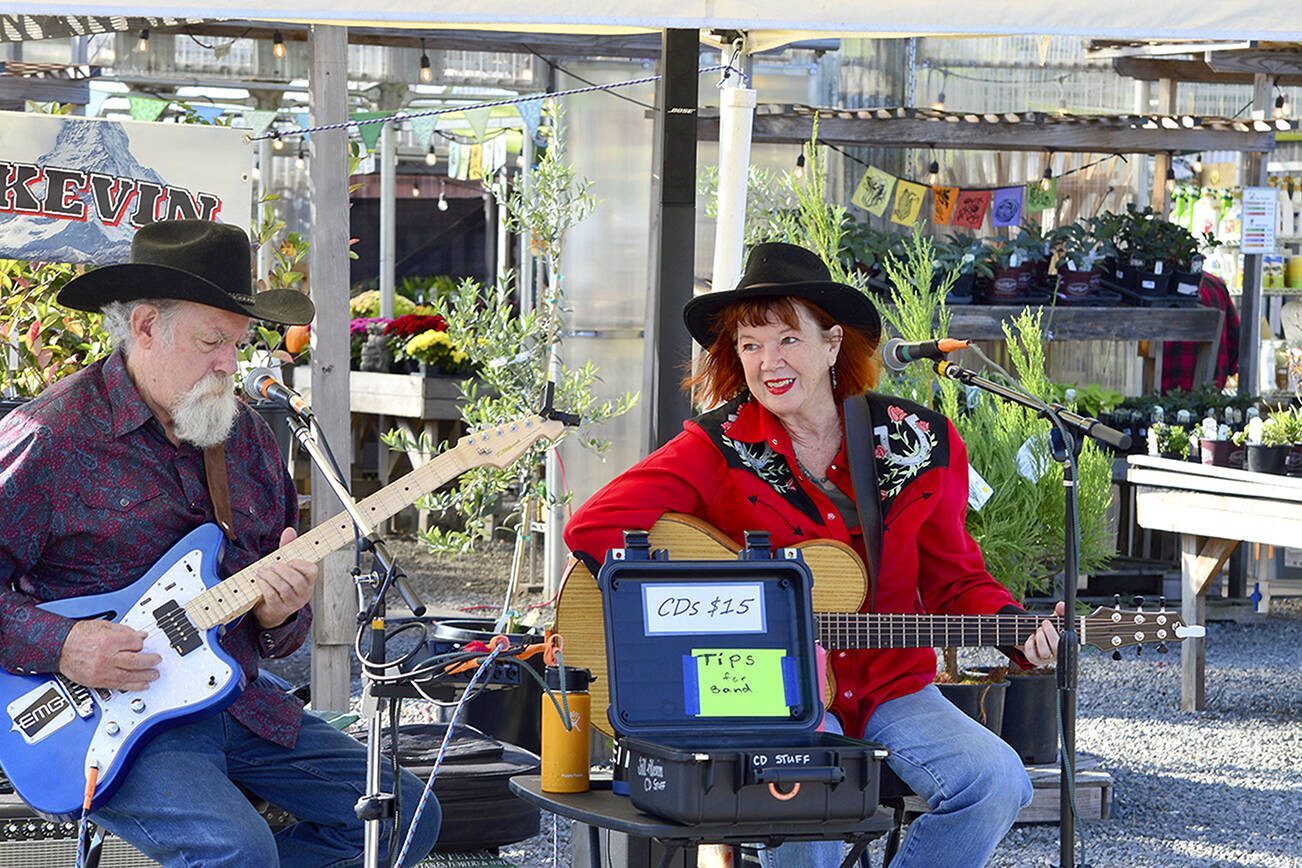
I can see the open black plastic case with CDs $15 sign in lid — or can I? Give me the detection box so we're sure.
[598,531,887,824]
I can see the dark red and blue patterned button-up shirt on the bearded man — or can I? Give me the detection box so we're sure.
[0,350,311,747]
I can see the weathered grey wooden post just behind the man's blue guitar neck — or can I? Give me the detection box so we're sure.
[300,25,357,711]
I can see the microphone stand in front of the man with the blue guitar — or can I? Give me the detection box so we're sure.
[289,413,426,868]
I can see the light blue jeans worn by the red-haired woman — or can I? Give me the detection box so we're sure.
[760,685,1031,868]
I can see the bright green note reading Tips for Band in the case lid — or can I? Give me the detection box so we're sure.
[691,648,790,717]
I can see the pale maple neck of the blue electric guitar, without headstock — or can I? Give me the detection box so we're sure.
[185,445,468,630]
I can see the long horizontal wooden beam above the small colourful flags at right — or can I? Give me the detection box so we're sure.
[698,111,1275,154]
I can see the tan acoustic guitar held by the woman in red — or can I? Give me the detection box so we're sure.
[555,513,1203,737]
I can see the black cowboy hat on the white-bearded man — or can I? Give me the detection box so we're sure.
[59,220,315,325]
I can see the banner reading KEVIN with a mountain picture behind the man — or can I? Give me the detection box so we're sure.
[0,112,253,265]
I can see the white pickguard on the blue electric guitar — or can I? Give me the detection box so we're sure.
[86,549,236,776]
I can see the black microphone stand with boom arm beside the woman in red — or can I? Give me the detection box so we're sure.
[935,360,1130,868]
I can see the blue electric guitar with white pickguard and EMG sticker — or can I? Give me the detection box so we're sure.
[0,416,562,819]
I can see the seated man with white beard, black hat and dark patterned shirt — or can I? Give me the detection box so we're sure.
[0,220,441,868]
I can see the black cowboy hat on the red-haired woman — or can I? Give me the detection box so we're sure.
[682,242,881,346]
